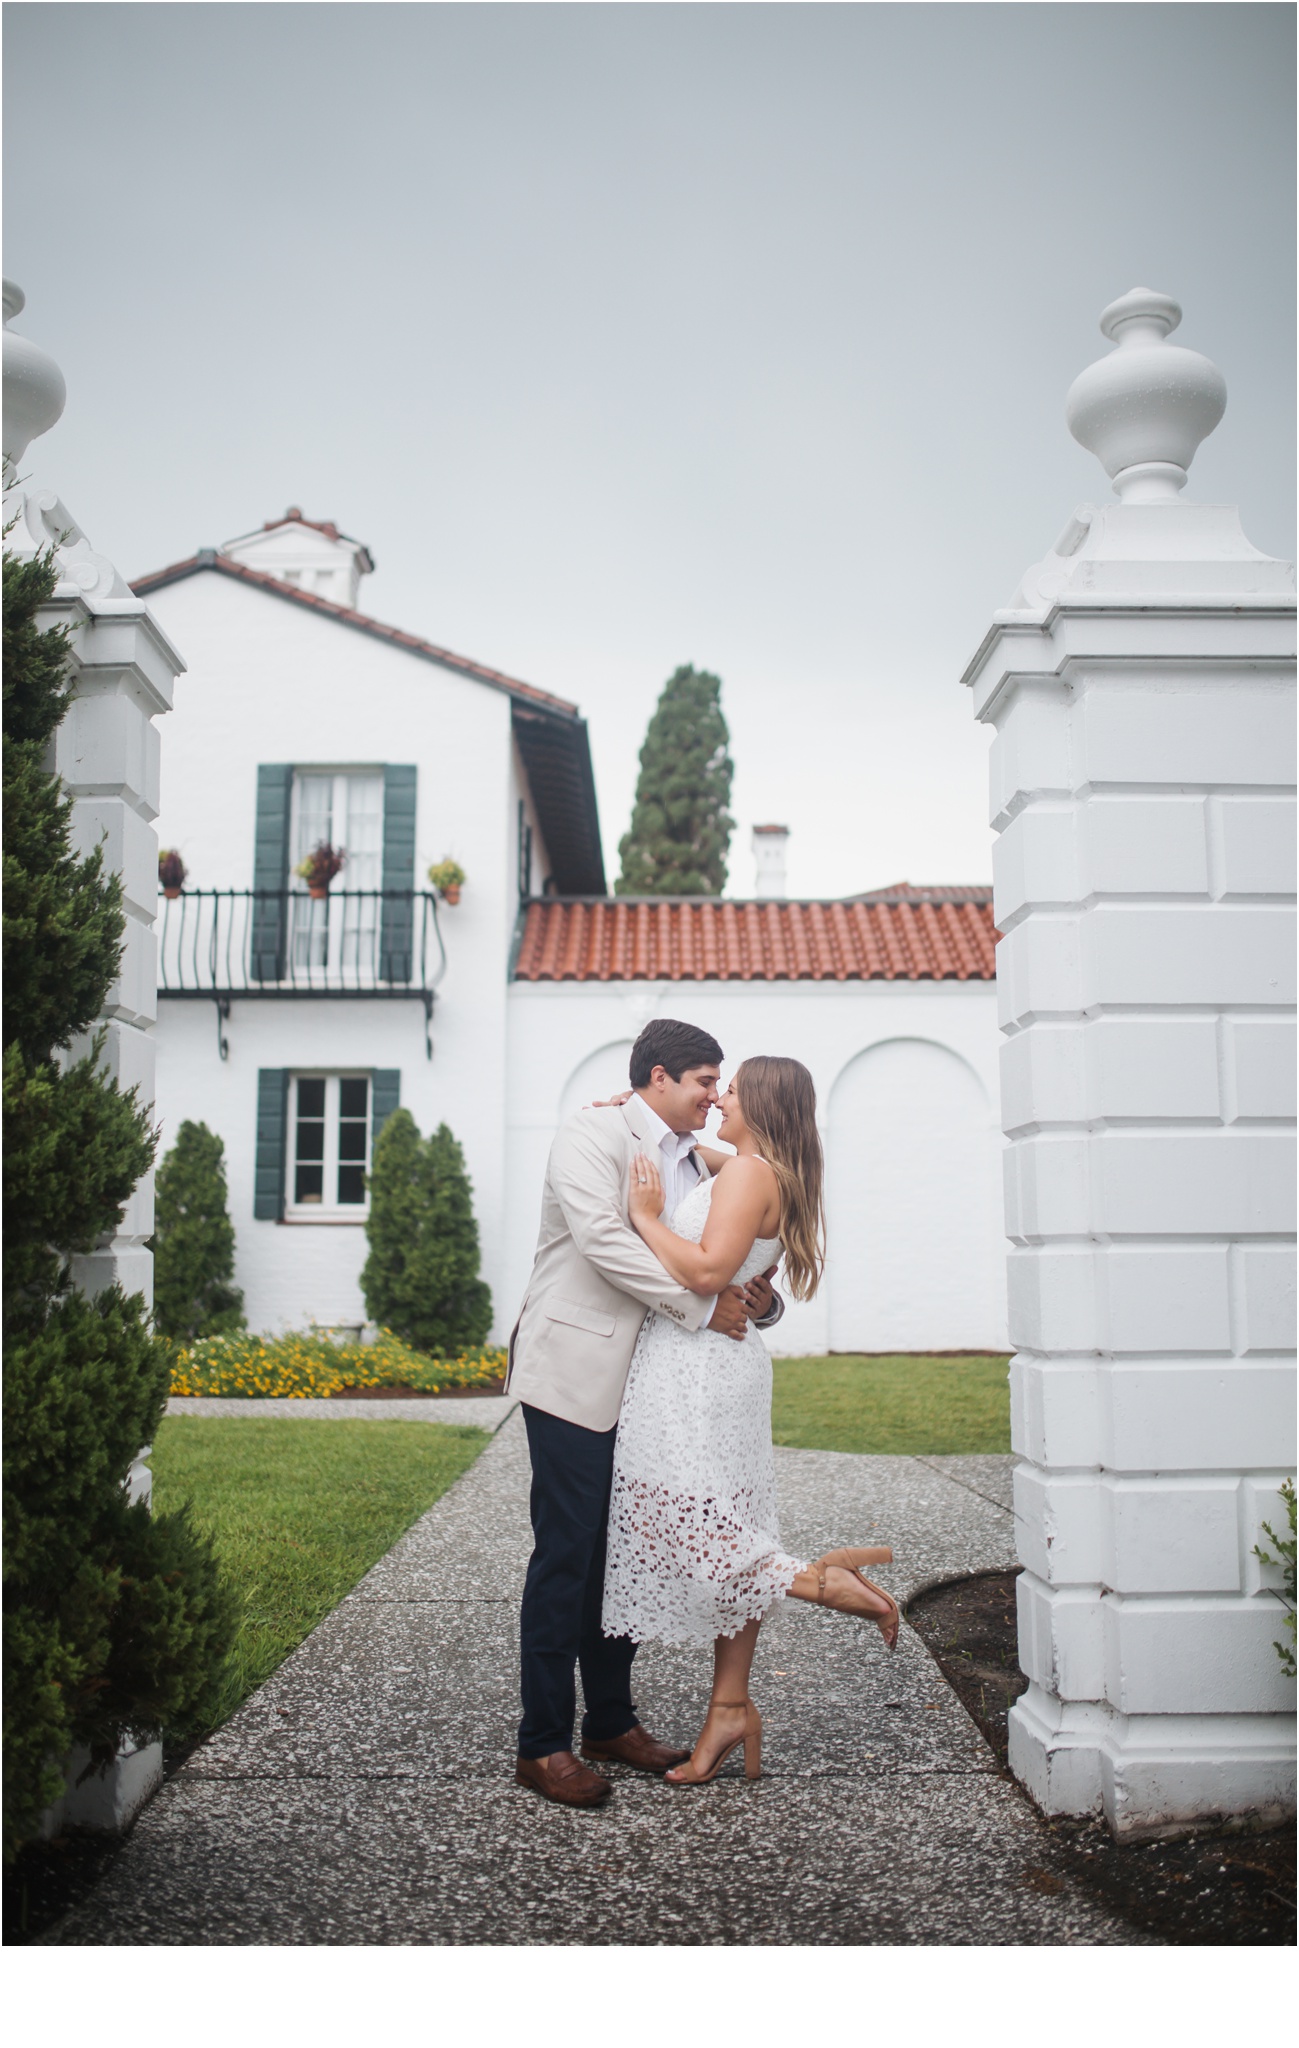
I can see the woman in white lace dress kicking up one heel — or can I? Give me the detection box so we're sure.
[602,1059,897,1786]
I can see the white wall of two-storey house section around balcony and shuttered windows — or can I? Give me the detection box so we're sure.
[150,573,524,1335]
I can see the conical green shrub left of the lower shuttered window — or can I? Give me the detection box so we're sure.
[154,1120,244,1343]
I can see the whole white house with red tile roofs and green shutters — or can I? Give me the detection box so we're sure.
[133,524,1006,1352]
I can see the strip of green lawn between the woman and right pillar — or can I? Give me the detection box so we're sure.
[770,1358,1010,1454]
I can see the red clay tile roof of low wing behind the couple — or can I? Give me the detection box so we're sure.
[514,889,1000,981]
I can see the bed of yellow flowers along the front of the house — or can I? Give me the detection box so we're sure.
[172,1329,506,1401]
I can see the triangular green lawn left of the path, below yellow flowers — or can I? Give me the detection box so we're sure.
[150,1415,490,1726]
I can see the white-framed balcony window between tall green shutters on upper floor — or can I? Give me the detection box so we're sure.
[289,768,383,975]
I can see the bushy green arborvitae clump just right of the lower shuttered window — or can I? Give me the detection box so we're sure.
[361,1110,492,1358]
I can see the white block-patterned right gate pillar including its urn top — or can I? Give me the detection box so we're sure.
[963,291,1295,1833]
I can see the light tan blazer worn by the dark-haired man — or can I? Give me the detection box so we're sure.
[506,1096,713,1430]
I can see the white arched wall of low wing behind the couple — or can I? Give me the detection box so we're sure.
[497,981,1006,1354]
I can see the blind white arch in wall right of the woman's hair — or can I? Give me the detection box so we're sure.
[826,1038,1006,1352]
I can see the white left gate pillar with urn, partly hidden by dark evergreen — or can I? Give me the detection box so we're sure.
[4,283,184,1829]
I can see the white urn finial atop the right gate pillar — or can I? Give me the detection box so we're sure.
[1065,285,1227,504]
